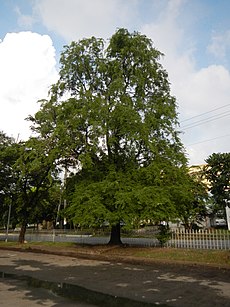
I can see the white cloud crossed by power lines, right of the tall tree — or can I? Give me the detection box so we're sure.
[179,65,230,164]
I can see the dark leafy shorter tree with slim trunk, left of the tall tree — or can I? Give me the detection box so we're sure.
[0,132,60,242]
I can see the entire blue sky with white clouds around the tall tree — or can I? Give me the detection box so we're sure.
[0,0,230,164]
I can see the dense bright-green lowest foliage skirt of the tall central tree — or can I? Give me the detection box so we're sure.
[66,165,185,230]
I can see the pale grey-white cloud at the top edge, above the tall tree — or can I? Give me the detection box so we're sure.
[35,0,138,41]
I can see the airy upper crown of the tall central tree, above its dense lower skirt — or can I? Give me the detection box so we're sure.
[30,29,184,168]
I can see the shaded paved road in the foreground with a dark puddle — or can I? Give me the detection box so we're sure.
[0,250,230,307]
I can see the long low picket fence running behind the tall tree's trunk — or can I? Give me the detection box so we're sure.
[0,228,230,250]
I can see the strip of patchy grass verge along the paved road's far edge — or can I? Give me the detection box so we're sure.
[0,241,230,268]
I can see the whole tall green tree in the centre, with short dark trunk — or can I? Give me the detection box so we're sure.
[30,29,186,243]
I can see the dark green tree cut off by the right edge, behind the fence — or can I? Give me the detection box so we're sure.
[205,153,230,217]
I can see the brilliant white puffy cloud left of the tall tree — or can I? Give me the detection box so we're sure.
[0,32,57,139]
